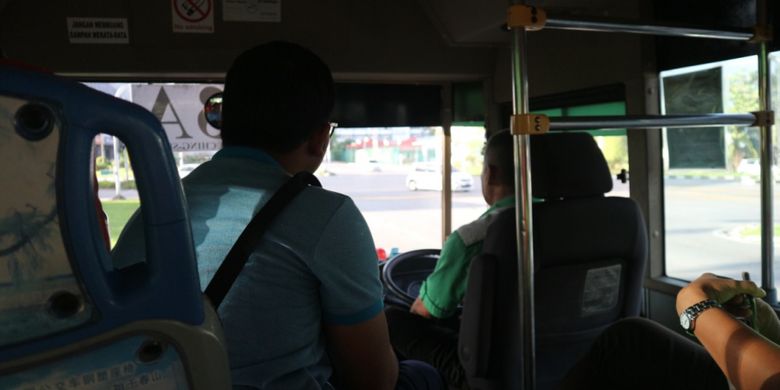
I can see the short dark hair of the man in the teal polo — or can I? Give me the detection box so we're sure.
[221,41,335,153]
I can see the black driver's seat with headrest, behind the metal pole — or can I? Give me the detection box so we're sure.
[461,133,647,389]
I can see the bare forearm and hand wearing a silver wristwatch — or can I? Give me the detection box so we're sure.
[677,273,780,389]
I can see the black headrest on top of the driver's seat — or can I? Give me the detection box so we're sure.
[531,132,612,199]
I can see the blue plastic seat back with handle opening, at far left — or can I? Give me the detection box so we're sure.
[0,65,230,389]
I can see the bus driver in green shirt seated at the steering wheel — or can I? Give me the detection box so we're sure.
[387,130,515,388]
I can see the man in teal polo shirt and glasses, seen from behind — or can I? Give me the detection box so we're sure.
[113,42,442,390]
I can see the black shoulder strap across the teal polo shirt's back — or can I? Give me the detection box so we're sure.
[205,172,321,309]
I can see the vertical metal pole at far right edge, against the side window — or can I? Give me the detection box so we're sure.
[756,0,777,303]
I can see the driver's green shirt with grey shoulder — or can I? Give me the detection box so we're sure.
[420,196,515,318]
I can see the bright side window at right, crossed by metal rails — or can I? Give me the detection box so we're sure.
[661,53,778,280]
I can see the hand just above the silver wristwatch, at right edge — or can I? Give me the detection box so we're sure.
[677,273,766,314]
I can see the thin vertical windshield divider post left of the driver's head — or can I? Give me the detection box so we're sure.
[441,84,452,242]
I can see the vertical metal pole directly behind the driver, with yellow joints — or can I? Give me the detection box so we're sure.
[512,2,536,390]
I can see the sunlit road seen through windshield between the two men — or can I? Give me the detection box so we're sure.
[318,127,487,256]
